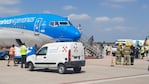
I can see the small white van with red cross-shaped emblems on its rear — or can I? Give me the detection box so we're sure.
[27,42,85,73]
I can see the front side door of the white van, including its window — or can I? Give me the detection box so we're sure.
[35,47,48,68]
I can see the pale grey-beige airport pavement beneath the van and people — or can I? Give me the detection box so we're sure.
[0,56,149,84]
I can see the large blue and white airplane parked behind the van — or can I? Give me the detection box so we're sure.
[0,14,81,46]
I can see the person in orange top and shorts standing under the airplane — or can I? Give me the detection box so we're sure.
[7,44,16,66]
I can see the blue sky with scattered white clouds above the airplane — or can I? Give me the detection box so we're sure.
[0,0,149,42]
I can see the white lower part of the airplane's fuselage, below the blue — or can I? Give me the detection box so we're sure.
[0,28,54,47]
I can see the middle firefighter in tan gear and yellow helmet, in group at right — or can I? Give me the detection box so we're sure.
[123,43,131,65]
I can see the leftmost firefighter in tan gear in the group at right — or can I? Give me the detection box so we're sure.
[115,43,123,65]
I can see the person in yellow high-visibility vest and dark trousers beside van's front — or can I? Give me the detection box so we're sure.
[20,43,27,68]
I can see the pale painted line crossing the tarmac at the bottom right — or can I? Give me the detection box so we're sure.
[64,73,149,84]
